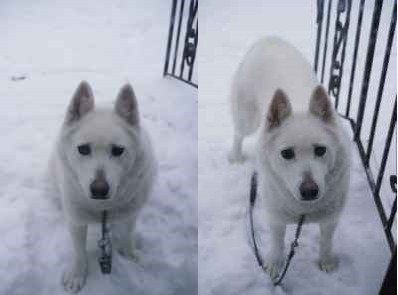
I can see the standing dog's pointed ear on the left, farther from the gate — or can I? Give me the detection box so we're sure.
[267,89,292,130]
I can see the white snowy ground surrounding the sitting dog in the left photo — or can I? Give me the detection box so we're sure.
[0,0,197,295]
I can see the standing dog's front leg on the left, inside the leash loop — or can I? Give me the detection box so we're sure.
[265,224,286,279]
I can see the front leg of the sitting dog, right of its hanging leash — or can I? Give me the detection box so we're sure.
[118,216,138,262]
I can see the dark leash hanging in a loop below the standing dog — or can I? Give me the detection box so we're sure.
[249,172,305,286]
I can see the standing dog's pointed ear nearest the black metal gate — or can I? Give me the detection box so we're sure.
[310,85,334,123]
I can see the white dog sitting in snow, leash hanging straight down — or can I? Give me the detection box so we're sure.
[50,81,155,292]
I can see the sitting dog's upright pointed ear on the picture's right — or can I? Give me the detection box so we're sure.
[115,84,140,126]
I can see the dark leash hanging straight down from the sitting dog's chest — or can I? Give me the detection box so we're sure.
[98,210,112,274]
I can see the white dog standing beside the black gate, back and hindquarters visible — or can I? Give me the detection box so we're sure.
[229,37,350,278]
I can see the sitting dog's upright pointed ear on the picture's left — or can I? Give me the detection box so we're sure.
[65,81,94,124]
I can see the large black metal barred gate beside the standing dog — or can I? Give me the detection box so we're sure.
[314,0,397,294]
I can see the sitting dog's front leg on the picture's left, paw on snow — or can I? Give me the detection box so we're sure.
[62,224,87,293]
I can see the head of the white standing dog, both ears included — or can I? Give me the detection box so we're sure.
[260,86,338,202]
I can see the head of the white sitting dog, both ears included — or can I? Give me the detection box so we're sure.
[63,81,141,204]
